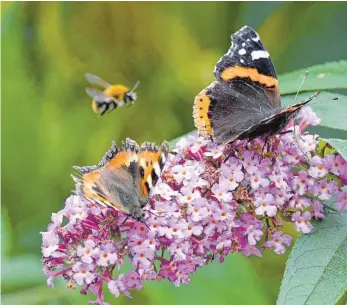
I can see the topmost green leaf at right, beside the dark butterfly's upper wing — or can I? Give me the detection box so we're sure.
[278,60,347,95]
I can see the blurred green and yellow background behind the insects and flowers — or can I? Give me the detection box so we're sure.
[1,2,347,305]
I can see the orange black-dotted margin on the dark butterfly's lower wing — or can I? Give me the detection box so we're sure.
[193,91,213,137]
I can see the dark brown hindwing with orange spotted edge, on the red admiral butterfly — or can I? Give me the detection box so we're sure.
[193,79,280,143]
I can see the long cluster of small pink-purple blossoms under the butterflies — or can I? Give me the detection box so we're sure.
[42,108,347,304]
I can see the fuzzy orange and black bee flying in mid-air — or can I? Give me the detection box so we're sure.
[85,73,140,115]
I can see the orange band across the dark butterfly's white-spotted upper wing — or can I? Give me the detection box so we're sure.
[222,66,278,90]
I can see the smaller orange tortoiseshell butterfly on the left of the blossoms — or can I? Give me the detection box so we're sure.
[74,138,168,211]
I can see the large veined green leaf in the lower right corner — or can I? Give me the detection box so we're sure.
[277,213,347,305]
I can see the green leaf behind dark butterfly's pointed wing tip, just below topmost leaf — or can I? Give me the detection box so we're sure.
[282,92,347,131]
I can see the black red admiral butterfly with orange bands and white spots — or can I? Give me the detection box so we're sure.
[193,26,319,143]
